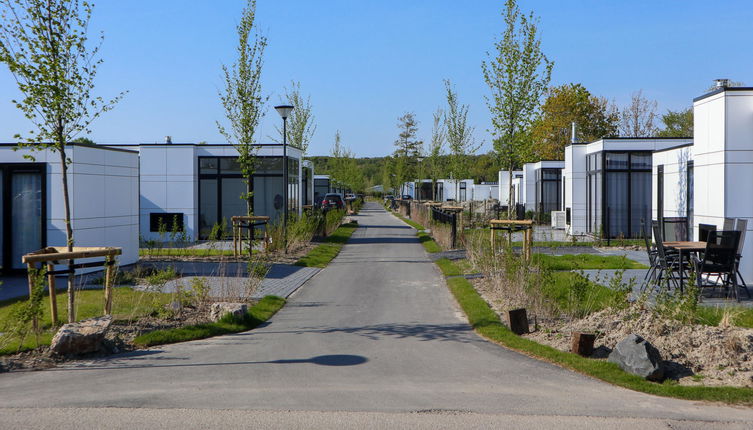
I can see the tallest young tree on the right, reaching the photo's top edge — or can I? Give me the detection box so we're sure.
[481,0,554,216]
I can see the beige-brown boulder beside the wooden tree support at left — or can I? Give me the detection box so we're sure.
[50,315,112,355]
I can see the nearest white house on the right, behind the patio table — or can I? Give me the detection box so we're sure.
[652,85,753,282]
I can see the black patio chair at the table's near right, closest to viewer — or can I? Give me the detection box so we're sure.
[694,230,740,301]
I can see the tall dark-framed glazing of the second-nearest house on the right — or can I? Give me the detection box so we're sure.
[586,151,651,238]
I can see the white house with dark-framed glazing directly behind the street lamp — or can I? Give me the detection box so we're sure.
[108,143,303,240]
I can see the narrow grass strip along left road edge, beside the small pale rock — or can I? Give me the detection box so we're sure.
[134,296,285,347]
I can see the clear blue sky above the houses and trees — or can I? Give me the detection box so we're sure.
[0,0,753,156]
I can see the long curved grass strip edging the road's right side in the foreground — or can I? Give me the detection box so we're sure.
[438,262,753,404]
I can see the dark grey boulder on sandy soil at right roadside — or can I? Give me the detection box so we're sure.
[608,334,664,381]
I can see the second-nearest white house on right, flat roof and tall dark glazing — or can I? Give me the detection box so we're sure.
[563,138,693,238]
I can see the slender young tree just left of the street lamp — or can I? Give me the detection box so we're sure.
[217,0,268,215]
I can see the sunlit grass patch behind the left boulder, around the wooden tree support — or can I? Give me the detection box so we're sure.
[0,287,172,355]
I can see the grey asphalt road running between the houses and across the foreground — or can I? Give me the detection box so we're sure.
[0,204,753,429]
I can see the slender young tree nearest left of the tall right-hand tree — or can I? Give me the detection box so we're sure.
[444,79,481,202]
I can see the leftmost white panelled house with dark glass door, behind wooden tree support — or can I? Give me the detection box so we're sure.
[0,144,139,274]
